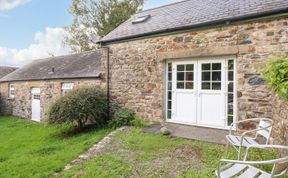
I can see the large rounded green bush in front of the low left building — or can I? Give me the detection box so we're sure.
[48,87,108,128]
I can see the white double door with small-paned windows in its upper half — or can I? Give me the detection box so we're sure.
[171,60,226,127]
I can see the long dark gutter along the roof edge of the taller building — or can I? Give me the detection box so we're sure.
[97,7,288,46]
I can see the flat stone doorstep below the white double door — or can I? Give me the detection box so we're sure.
[144,122,229,144]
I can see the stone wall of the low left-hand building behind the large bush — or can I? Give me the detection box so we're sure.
[0,79,106,120]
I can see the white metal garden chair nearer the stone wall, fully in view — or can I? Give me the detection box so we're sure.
[226,118,273,160]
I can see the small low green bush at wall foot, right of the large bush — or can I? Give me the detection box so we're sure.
[109,108,136,128]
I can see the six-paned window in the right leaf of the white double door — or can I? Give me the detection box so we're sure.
[201,63,222,90]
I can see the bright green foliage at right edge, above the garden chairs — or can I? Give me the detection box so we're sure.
[261,54,288,100]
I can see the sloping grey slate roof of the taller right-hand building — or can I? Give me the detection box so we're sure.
[99,0,288,43]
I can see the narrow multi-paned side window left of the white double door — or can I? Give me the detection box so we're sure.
[167,63,172,119]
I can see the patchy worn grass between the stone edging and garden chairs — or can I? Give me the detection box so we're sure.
[62,129,282,178]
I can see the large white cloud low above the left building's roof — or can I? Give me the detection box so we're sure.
[0,28,71,66]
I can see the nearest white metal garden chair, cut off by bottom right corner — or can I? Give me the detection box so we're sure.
[215,145,288,178]
